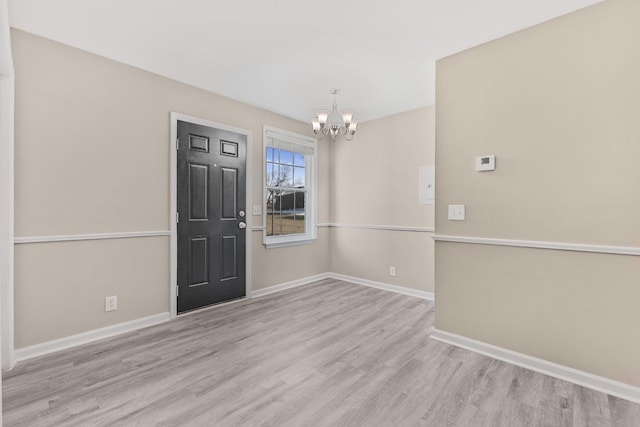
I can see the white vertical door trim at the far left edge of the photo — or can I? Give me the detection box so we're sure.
[0,0,15,380]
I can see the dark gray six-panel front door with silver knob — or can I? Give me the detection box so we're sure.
[178,121,247,313]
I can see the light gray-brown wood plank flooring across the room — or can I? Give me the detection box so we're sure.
[3,280,640,427]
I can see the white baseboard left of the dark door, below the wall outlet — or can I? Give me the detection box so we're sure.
[16,312,171,362]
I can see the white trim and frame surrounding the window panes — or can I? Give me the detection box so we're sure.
[262,125,318,249]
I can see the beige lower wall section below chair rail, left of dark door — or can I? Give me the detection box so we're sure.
[15,237,169,348]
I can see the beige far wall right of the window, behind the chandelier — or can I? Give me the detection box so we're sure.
[331,107,435,292]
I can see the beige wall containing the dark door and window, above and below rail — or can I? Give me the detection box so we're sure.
[12,31,331,348]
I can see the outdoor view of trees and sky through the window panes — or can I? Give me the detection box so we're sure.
[266,147,307,236]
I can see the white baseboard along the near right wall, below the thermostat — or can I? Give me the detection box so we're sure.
[431,329,640,403]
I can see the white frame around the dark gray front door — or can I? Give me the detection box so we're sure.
[169,111,253,319]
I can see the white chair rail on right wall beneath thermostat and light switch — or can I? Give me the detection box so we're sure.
[432,234,640,256]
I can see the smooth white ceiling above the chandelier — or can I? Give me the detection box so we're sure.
[9,0,599,121]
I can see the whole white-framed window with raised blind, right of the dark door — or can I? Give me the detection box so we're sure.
[263,126,316,248]
